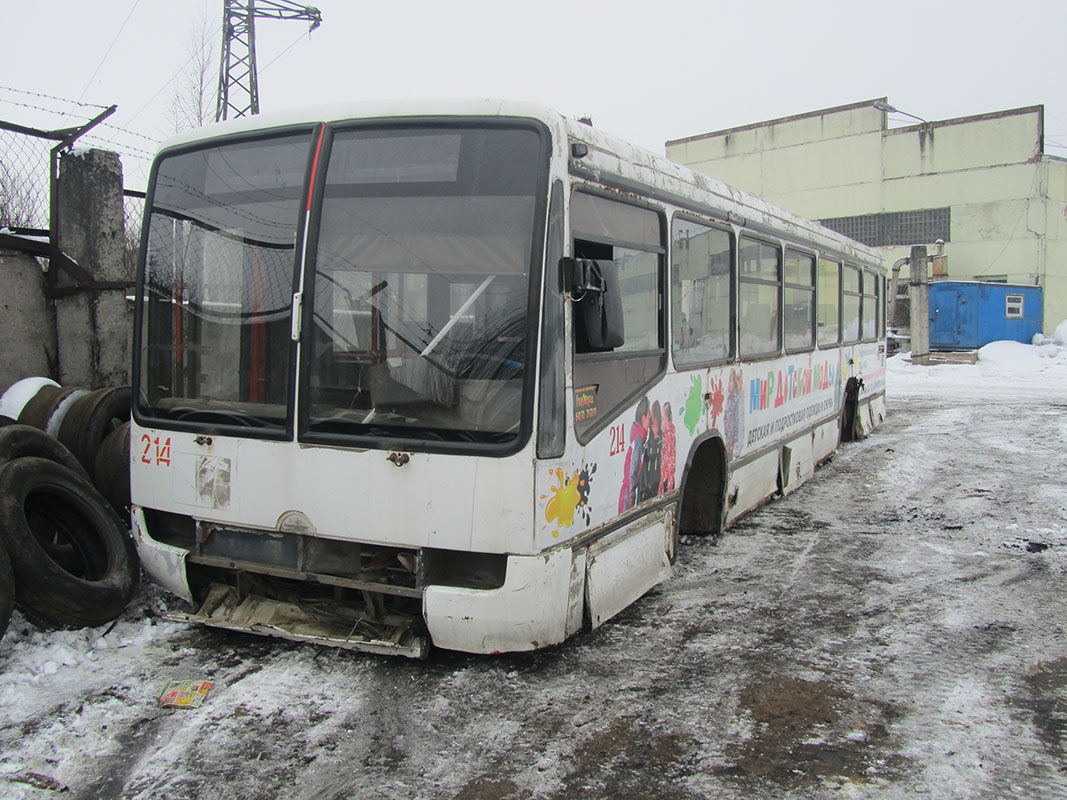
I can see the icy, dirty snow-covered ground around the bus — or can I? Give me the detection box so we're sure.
[0,332,1067,800]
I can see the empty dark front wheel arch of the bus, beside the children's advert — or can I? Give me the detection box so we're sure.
[676,431,729,535]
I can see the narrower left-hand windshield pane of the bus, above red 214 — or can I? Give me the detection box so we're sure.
[138,131,310,430]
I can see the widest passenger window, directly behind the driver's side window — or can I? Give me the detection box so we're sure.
[671,219,733,366]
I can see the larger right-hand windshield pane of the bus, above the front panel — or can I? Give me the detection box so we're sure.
[305,125,543,444]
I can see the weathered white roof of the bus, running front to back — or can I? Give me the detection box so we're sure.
[154,98,885,267]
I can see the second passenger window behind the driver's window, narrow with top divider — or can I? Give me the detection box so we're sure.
[738,238,782,356]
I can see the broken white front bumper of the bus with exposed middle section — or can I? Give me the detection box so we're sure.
[132,507,585,658]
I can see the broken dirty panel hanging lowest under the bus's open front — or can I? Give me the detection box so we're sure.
[166,583,429,658]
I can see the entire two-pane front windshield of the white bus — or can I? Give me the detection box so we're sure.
[138,123,545,444]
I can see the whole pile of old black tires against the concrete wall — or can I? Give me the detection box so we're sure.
[0,379,140,636]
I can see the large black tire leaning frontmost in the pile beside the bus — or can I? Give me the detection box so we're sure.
[0,457,141,627]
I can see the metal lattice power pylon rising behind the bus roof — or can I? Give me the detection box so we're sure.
[214,0,322,122]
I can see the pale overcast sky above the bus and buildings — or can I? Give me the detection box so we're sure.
[0,0,1067,188]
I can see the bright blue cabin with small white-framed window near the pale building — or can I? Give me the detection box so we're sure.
[929,281,1044,350]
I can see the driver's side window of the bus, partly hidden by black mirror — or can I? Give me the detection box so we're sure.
[571,192,667,444]
